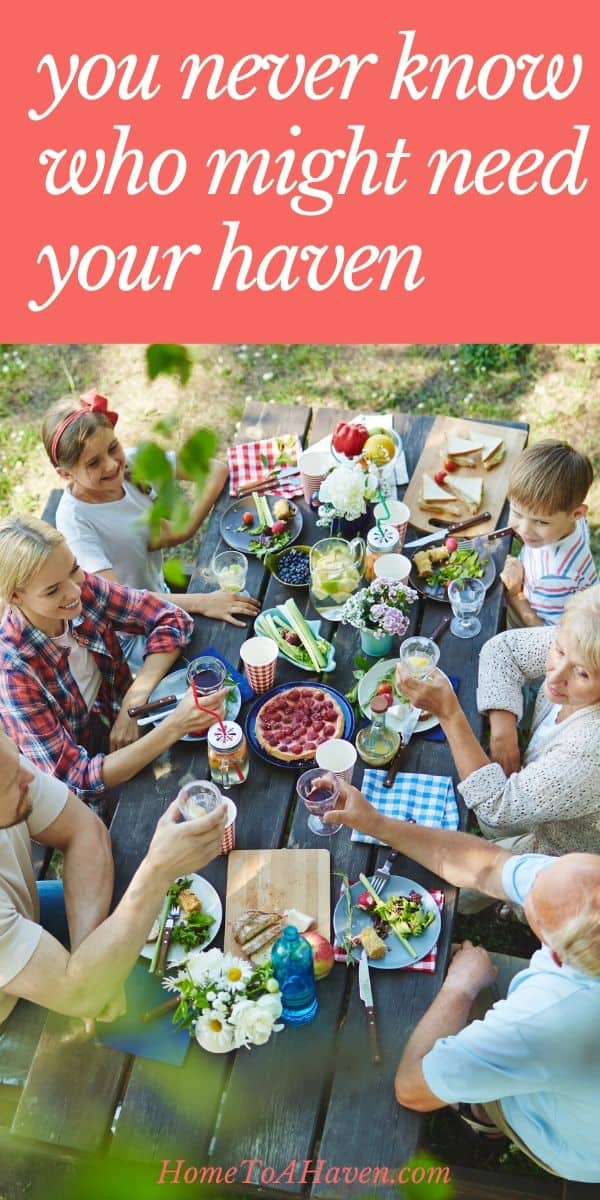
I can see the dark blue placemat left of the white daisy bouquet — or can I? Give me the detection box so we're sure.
[96,961,190,1067]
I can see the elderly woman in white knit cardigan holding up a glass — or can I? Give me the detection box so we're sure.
[398,584,600,878]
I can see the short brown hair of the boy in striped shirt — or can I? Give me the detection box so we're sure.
[508,438,594,516]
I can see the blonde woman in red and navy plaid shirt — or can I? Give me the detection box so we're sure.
[0,517,229,800]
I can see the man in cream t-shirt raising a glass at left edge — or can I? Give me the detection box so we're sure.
[0,732,226,1025]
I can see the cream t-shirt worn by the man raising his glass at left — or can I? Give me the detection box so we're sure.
[0,757,68,1024]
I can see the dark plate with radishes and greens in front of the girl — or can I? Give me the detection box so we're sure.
[221,492,302,558]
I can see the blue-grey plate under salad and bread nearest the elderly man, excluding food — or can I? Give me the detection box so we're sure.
[334,875,442,971]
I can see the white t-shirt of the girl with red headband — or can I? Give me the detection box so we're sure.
[56,450,175,592]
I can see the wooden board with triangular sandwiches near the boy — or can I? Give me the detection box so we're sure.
[404,416,527,538]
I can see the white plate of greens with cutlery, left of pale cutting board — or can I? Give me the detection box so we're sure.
[139,875,223,966]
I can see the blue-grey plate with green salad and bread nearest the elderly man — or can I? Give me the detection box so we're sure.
[334,875,442,971]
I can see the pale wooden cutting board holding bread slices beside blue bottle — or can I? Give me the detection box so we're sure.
[224,850,331,954]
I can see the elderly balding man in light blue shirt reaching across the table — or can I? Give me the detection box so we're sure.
[324,784,600,1183]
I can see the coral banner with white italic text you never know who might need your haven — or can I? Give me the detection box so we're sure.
[0,0,600,342]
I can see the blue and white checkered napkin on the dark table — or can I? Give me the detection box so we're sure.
[352,769,458,846]
